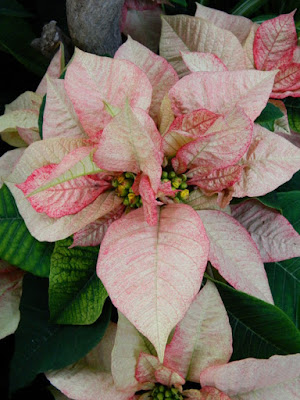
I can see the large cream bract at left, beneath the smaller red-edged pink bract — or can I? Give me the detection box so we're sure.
[7,138,122,242]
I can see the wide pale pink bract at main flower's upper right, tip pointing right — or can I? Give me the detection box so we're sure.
[169,70,276,120]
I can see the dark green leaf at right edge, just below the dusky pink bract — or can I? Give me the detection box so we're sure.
[265,258,300,328]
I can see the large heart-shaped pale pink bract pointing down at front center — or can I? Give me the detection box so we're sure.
[97,204,208,360]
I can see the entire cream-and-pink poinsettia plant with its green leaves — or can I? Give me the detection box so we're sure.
[0,1,300,400]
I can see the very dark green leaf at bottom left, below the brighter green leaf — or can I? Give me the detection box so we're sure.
[10,274,111,392]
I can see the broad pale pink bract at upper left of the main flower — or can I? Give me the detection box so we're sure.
[63,48,152,140]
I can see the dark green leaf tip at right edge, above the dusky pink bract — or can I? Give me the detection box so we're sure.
[257,190,300,233]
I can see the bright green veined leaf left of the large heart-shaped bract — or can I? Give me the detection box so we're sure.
[49,238,107,325]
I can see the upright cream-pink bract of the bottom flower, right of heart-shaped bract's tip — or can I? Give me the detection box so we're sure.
[164,281,232,383]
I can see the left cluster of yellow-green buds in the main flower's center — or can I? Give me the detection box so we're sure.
[112,172,142,208]
